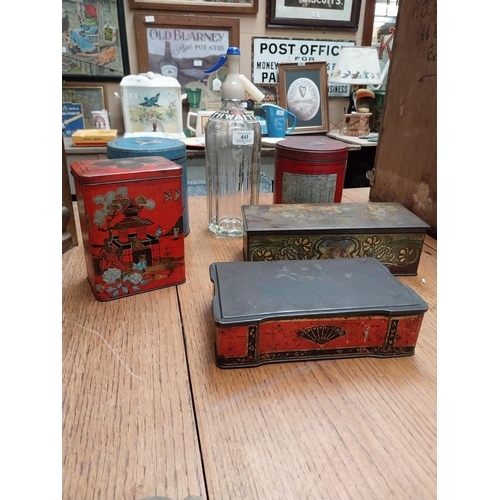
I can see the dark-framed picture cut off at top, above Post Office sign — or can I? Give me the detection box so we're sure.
[266,0,361,31]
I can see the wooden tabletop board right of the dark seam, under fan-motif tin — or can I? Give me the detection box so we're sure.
[178,188,436,500]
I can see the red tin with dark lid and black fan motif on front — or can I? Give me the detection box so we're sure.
[210,258,428,368]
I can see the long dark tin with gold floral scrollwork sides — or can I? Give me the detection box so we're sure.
[242,202,429,276]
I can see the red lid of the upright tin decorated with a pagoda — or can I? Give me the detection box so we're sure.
[70,156,182,184]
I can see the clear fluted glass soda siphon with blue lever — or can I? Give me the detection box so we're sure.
[205,47,263,237]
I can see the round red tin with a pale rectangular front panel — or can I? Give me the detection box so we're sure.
[274,135,348,204]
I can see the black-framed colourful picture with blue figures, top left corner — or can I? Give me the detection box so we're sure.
[62,0,130,81]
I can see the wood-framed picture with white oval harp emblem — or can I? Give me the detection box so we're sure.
[278,61,329,135]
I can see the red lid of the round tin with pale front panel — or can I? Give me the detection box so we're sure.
[275,135,348,161]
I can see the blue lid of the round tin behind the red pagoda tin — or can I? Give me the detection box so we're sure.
[107,137,186,160]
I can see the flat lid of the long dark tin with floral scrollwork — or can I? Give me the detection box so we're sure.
[241,202,430,233]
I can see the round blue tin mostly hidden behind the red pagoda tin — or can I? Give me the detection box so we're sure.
[107,137,189,237]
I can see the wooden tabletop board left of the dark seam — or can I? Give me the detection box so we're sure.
[62,215,206,500]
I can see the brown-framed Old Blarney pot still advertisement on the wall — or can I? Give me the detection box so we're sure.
[134,14,240,86]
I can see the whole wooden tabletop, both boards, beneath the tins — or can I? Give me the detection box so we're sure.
[62,188,437,500]
